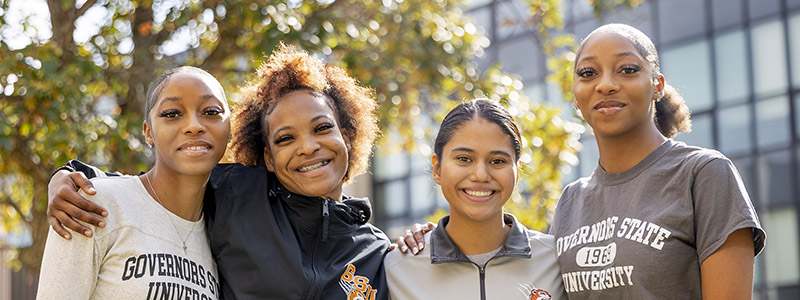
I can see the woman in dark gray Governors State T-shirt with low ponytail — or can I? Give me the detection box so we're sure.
[550,24,765,299]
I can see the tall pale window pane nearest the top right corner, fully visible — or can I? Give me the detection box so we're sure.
[751,20,788,95]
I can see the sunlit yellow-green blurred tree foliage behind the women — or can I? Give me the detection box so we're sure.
[0,0,638,270]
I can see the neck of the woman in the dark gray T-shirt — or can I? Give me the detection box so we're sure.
[596,124,667,173]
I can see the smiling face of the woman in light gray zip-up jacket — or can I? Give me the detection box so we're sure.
[433,117,519,222]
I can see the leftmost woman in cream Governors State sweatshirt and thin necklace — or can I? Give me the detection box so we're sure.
[37,67,231,299]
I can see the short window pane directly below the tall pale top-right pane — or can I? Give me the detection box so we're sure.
[756,96,791,147]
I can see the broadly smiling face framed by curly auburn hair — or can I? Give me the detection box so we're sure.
[264,90,348,200]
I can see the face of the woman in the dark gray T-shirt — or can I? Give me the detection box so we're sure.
[573,32,664,138]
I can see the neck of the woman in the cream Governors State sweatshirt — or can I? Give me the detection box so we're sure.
[139,167,211,221]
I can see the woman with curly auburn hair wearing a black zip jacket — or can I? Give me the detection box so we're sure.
[50,45,389,299]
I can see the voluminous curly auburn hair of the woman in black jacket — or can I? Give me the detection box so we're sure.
[231,44,379,183]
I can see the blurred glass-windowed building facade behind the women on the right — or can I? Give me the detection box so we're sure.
[371,0,800,299]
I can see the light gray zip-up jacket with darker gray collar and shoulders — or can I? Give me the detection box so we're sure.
[383,214,567,300]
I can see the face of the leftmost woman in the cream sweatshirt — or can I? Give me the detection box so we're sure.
[143,73,231,176]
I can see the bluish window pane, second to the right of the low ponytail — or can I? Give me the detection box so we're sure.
[717,104,752,154]
